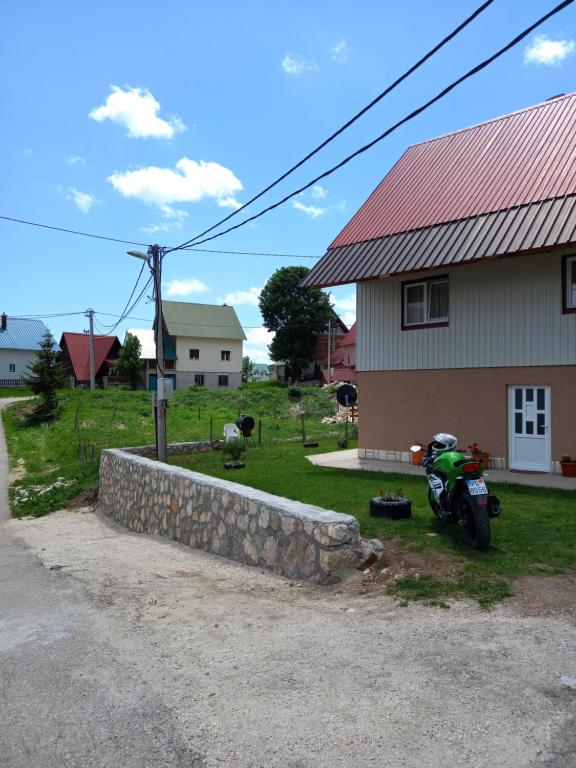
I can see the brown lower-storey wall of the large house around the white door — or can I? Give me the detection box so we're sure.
[357,365,576,462]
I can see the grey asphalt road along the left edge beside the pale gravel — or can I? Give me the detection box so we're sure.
[0,400,202,768]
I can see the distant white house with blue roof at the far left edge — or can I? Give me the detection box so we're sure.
[0,313,48,387]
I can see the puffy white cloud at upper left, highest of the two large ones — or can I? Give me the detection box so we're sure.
[89,85,186,139]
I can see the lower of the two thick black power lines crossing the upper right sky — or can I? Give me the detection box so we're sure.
[173,0,574,252]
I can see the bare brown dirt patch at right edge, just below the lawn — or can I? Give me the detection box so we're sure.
[506,573,576,617]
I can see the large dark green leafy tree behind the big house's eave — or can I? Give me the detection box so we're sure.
[259,267,333,378]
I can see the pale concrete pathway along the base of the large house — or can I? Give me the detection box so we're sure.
[306,448,576,491]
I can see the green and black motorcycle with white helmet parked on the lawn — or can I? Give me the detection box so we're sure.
[410,433,501,550]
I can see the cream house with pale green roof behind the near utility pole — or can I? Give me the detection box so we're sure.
[162,301,246,389]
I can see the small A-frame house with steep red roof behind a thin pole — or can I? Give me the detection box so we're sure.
[60,331,120,386]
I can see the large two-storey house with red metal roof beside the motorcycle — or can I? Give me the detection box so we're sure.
[302,93,576,472]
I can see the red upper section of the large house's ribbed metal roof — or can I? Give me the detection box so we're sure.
[330,93,576,248]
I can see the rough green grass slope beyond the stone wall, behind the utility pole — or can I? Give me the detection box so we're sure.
[4,383,343,517]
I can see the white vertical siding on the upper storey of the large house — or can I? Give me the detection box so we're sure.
[356,253,576,371]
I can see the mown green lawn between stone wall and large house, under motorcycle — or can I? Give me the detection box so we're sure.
[171,441,576,606]
